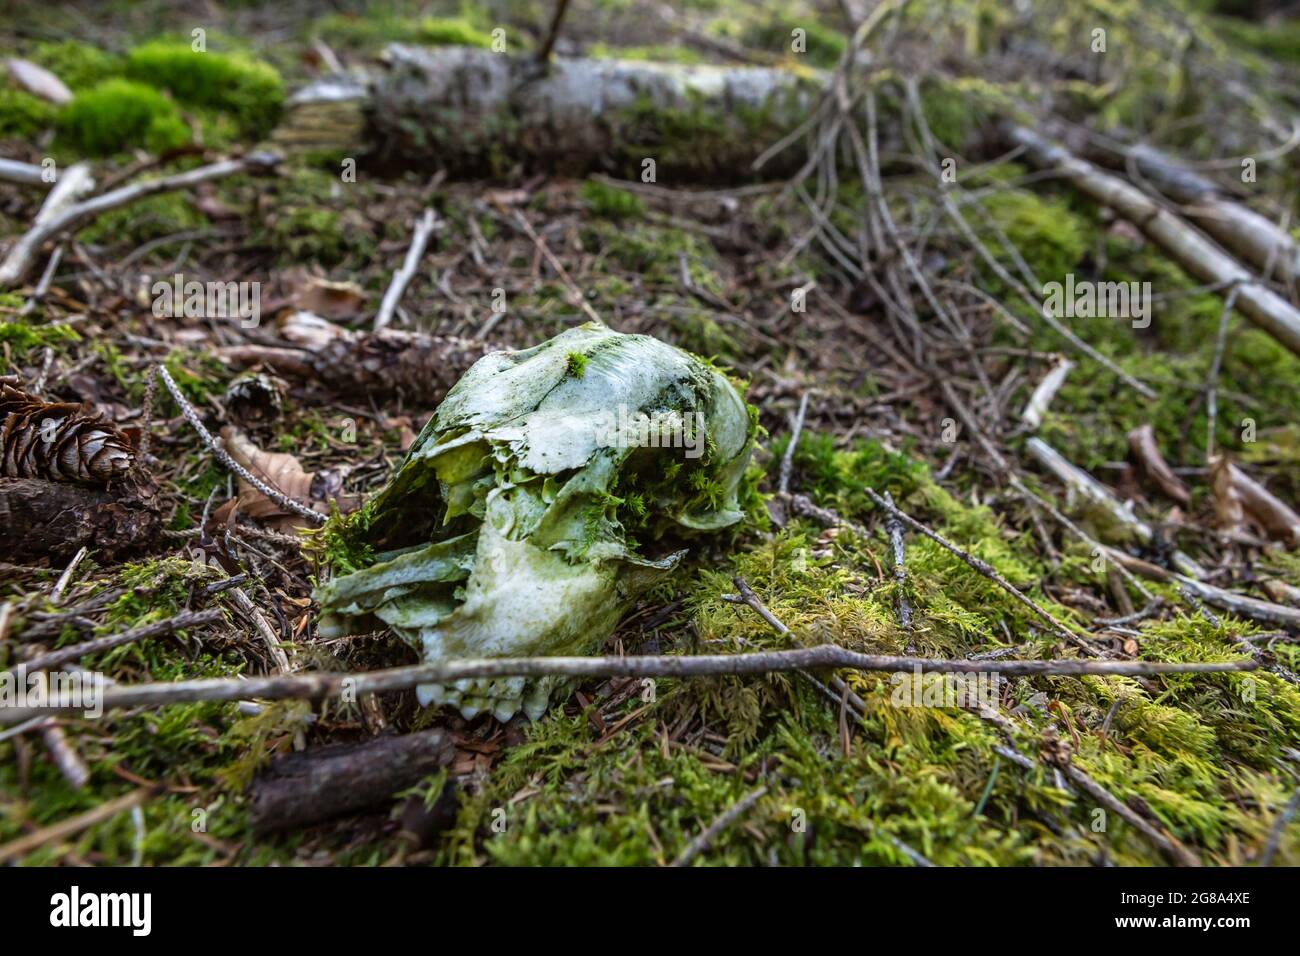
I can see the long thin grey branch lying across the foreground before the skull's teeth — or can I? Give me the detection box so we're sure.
[0,644,1260,726]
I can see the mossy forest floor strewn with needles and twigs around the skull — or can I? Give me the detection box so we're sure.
[0,0,1300,865]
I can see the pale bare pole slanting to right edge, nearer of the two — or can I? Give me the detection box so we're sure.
[1006,126,1300,355]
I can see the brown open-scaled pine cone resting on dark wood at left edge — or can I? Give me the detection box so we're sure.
[0,376,135,485]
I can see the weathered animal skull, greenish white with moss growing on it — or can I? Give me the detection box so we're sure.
[317,323,757,719]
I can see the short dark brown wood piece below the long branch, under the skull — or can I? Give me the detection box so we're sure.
[250,730,456,834]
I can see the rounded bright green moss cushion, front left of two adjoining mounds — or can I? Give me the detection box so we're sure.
[59,79,190,156]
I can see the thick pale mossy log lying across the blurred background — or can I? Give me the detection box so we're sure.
[276,44,824,181]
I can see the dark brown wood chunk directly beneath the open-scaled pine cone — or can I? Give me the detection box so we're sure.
[0,479,163,561]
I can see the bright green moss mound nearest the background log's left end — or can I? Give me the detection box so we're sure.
[126,42,285,135]
